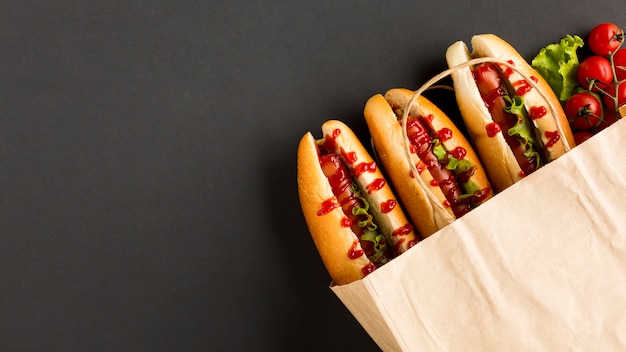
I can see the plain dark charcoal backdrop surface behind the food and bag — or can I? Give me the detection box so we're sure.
[0,0,626,351]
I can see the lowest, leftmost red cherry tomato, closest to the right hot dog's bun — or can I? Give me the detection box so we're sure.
[563,92,602,130]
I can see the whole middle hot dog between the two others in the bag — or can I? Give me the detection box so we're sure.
[364,88,493,237]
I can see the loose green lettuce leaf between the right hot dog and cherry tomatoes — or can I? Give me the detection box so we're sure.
[531,35,584,102]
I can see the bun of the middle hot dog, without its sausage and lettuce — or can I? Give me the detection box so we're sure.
[364,88,493,237]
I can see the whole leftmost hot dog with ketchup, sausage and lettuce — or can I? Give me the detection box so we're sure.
[297,120,419,285]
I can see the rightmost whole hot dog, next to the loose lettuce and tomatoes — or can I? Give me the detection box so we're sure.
[446,34,575,191]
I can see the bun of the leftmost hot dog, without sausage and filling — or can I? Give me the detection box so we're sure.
[297,120,419,285]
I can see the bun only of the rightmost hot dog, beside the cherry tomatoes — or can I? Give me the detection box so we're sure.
[446,34,575,191]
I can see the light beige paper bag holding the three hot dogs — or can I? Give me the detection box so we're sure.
[331,119,626,351]
